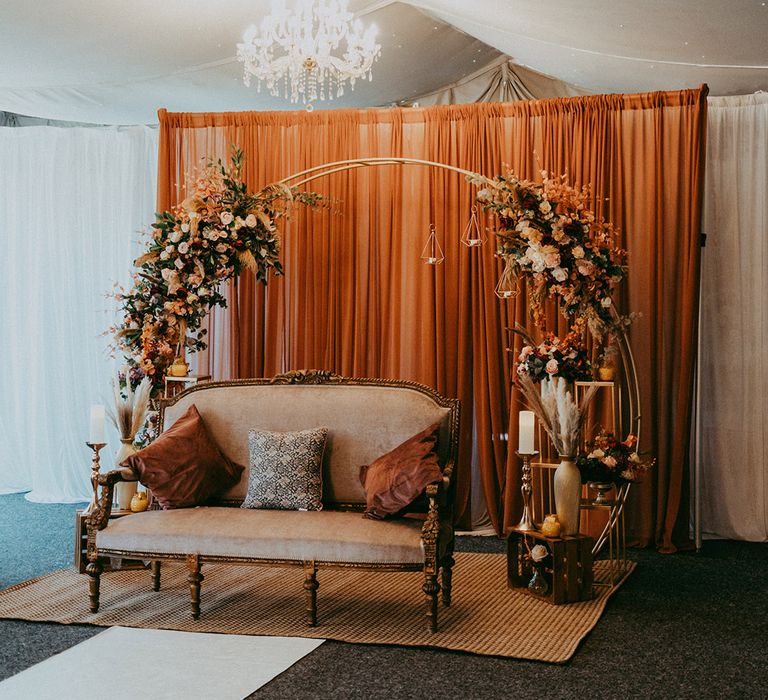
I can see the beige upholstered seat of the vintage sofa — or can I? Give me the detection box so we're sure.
[96,507,424,564]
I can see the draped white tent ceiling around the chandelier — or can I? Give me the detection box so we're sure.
[0,0,768,123]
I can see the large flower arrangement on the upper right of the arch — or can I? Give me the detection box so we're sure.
[471,171,626,338]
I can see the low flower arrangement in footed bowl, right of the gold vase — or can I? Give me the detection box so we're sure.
[576,431,653,485]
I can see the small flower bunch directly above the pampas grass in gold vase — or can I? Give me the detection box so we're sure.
[517,331,592,383]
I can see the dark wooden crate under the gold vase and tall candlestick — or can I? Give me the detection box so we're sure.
[507,531,594,605]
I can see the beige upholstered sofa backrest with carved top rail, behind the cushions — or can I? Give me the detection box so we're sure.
[156,371,459,505]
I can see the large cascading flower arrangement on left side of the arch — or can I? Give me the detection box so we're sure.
[110,148,321,391]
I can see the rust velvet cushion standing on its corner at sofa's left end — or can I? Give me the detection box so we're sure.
[120,404,243,508]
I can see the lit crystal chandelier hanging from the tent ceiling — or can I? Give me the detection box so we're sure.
[237,0,381,109]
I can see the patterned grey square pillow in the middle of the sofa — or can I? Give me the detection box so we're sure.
[242,428,328,510]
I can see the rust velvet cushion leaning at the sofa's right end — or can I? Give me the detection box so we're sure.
[360,423,443,520]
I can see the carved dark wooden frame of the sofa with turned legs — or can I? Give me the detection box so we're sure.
[86,370,459,632]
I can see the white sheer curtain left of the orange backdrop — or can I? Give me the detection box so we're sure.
[0,126,157,502]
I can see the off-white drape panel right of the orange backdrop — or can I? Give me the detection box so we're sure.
[700,93,768,541]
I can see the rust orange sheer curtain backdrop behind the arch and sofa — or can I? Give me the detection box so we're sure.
[158,88,706,549]
